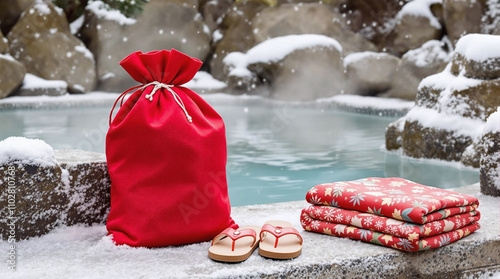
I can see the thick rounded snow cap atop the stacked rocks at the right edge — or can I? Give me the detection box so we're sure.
[455,34,500,62]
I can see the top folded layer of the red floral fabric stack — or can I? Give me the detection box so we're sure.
[306,177,479,224]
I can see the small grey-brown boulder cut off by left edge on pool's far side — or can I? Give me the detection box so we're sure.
[0,54,26,99]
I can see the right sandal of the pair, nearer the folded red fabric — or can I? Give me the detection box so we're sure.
[259,220,303,259]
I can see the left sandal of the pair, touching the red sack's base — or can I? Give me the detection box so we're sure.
[208,226,260,262]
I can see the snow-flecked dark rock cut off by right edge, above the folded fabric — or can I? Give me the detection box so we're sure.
[479,132,500,197]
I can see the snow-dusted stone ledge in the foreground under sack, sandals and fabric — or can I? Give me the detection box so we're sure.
[0,184,500,279]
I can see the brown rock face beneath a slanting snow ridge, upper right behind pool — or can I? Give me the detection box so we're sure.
[391,7,442,55]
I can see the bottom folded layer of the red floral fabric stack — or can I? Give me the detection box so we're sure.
[300,209,479,251]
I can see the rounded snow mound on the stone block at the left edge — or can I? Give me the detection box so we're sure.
[0,137,57,167]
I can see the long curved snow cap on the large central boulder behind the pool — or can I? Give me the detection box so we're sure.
[223,34,342,76]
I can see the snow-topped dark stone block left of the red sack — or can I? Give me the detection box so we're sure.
[0,137,110,240]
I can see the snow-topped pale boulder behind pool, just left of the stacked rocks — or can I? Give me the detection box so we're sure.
[381,40,450,100]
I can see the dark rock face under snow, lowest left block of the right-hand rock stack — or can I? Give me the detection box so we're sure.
[402,121,472,161]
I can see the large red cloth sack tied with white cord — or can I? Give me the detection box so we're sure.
[106,49,237,247]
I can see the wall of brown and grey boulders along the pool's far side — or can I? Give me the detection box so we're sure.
[0,0,500,100]
